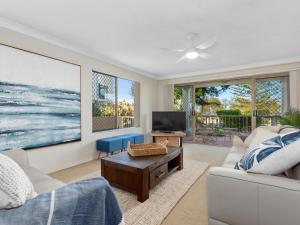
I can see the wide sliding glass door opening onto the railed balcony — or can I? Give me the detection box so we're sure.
[174,76,289,145]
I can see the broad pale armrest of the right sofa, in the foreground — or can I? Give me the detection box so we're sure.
[207,167,300,225]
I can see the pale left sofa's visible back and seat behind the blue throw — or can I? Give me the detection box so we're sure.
[2,149,66,194]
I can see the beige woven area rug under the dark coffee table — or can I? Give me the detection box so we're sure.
[73,160,209,225]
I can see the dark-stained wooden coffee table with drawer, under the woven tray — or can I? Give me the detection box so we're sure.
[101,147,183,202]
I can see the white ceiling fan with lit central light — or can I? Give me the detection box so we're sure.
[161,33,217,63]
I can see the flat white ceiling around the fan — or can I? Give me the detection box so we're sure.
[0,0,300,79]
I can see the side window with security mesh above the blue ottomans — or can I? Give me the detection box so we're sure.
[92,71,140,132]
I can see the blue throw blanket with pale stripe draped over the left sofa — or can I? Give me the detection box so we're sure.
[0,177,123,225]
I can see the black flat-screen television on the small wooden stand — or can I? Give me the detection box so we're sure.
[152,111,186,132]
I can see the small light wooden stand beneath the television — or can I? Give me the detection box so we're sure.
[150,131,185,147]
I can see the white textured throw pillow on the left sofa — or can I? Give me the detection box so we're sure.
[0,154,37,209]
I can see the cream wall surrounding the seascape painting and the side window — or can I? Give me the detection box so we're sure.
[0,27,158,173]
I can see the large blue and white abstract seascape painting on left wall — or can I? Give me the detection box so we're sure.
[0,45,81,151]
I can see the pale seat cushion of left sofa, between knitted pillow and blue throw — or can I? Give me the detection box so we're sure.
[22,166,65,194]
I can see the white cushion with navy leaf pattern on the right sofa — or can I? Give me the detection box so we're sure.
[235,130,300,175]
